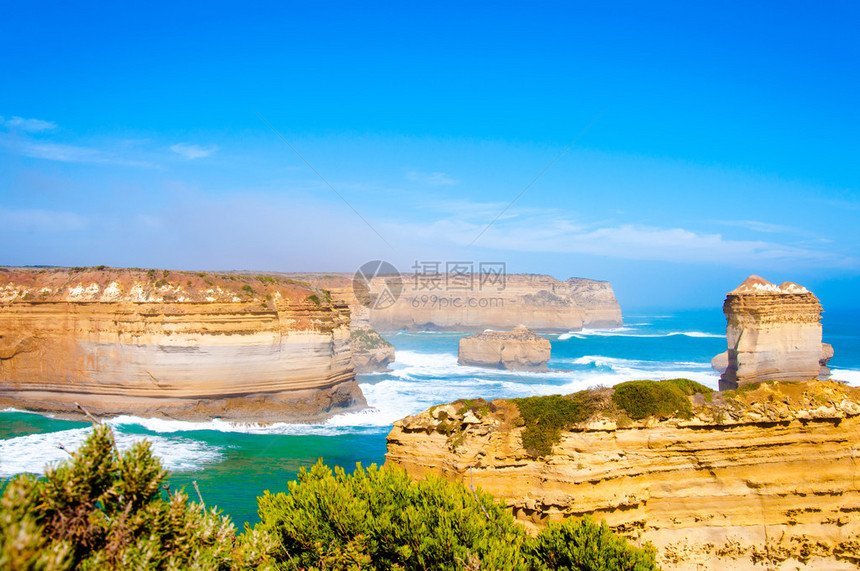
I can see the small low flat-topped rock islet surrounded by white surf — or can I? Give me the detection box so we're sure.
[457,327,550,371]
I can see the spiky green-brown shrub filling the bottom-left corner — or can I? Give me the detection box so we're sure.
[0,426,255,570]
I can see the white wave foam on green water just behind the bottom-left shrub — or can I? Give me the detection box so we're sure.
[0,428,224,478]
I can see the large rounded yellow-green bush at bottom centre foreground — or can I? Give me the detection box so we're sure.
[254,462,527,571]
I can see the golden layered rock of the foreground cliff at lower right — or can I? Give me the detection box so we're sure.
[386,381,860,570]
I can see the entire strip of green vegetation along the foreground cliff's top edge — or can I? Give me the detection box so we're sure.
[513,379,713,458]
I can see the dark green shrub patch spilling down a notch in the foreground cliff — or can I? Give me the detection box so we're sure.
[514,391,599,458]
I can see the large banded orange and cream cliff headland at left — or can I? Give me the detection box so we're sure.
[0,269,365,421]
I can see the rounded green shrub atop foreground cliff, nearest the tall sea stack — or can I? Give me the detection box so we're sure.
[612,381,693,420]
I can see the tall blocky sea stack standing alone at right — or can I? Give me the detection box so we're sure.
[720,276,832,390]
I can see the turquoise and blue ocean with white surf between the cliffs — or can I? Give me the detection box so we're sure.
[0,308,860,529]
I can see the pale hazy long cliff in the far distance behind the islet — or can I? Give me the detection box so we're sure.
[370,274,621,332]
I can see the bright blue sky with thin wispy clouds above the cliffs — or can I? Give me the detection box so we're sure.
[0,2,860,308]
